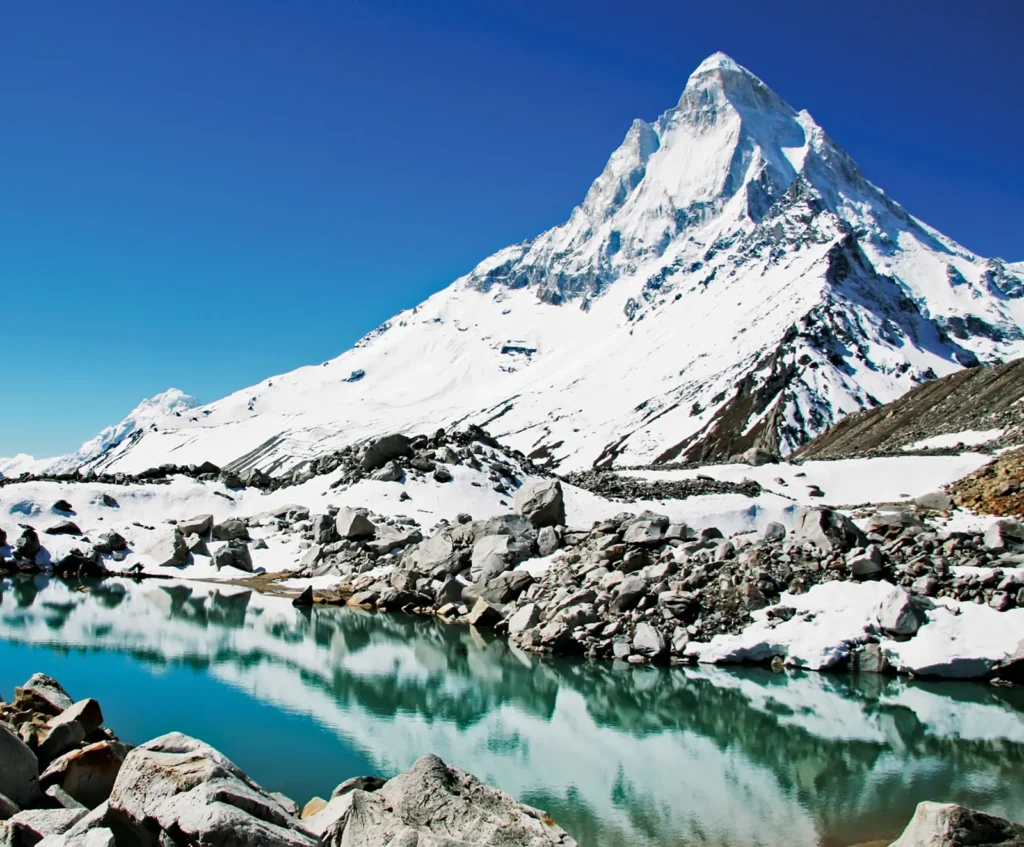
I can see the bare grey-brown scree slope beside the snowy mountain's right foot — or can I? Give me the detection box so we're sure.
[793,359,1024,459]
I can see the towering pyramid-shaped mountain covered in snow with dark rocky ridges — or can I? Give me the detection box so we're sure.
[9,53,1024,472]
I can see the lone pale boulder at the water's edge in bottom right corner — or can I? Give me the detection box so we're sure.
[890,803,1024,847]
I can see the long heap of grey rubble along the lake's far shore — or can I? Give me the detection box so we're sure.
[309,499,1024,668]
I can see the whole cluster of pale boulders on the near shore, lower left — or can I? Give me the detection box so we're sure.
[0,674,575,847]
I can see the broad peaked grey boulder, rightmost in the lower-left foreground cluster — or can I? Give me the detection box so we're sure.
[322,756,577,847]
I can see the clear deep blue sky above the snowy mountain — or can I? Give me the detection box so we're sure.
[0,0,1024,456]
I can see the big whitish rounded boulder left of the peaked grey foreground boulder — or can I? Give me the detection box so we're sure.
[109,732,316,847]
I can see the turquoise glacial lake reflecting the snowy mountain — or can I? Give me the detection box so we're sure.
[0,577,1024,847]
